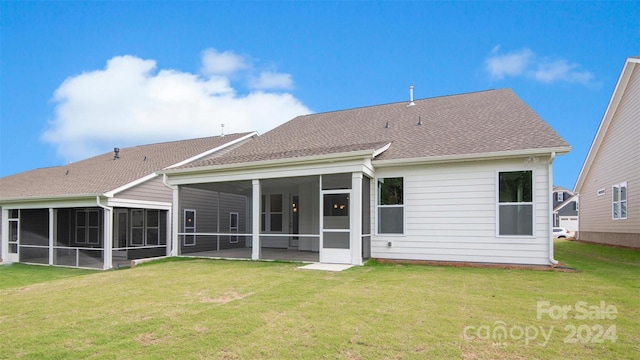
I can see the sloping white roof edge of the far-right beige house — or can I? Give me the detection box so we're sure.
[573,56,640,193]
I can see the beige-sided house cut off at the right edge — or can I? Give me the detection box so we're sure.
[574,57,640,248]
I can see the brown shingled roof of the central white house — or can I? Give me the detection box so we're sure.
[172,89,570,172]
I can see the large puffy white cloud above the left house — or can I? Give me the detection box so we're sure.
[42,52,310,161]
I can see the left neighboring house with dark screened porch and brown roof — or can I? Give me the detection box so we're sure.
[0,133,257,269]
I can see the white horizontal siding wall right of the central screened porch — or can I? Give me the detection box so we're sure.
[371,158,551,265]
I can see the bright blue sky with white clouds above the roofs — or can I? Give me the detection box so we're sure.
[0,1,640,189]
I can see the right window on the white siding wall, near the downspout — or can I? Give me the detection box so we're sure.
[498,170,533,236]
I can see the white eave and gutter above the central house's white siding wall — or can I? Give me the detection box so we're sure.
[372,146,571,167]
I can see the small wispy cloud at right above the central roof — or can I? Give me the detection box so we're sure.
[485,46,593,85]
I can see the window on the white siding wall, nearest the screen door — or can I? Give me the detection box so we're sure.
[376,177,404,234]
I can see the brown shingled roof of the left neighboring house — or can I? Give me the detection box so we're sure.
[0,133,256,201]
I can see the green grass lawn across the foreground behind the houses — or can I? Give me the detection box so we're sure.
[0,240,640,359]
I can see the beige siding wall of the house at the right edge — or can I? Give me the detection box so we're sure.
[579,66,640,240]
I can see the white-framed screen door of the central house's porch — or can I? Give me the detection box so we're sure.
[320,190,351,264]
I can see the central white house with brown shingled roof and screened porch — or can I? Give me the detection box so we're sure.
[160,89,570,265]
